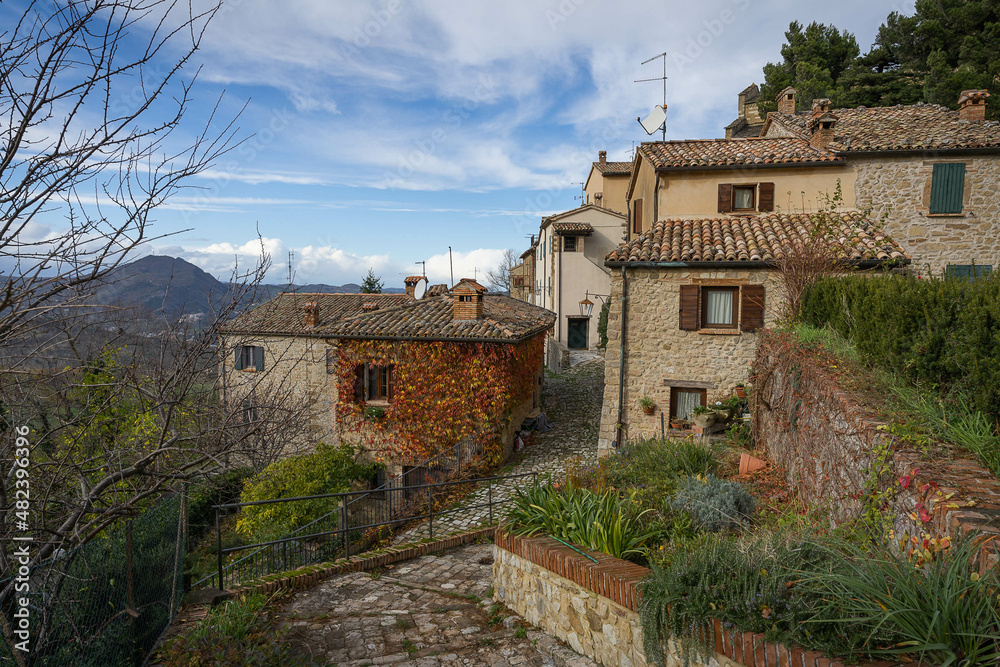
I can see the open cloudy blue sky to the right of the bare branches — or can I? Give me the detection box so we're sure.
[11,0,913,287]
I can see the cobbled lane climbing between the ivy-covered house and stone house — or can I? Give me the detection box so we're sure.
[396,357,604,544]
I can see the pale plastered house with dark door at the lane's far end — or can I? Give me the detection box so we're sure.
[523,204,625,372]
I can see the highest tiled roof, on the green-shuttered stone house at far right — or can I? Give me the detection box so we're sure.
[764,102,1000,153]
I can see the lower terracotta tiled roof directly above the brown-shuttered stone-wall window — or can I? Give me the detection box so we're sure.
[605,211,909,264]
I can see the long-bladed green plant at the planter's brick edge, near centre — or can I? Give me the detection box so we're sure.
[507,484,650,558]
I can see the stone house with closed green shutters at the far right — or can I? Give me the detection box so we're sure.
[762,88,1000,274]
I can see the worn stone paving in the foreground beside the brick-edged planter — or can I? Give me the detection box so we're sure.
[278,544,596,667]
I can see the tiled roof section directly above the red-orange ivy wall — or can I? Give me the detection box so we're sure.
[321,294,556,343]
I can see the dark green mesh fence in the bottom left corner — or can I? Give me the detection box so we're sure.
[0,494,185,667]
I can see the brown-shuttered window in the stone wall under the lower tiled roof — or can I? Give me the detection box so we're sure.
[678,285,764,332]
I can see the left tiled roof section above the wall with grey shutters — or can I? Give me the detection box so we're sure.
[222,292,413,335]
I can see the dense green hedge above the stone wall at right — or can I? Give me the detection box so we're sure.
[800,275,1000,420]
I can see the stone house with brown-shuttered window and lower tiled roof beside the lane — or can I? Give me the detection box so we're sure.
[598,212,908,455]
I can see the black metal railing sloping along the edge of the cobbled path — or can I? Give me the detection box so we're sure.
[195,473,538,588]
